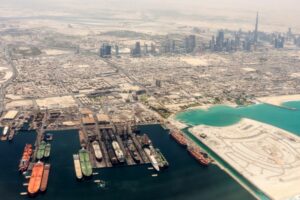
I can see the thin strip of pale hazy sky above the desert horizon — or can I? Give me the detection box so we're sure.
[0,0,300,12]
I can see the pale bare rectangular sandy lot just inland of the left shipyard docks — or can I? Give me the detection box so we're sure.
[36,96,77,109]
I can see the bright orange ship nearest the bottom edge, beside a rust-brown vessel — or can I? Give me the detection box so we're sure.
[27,161,44,196]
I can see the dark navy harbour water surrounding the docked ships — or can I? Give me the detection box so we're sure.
[0,125,254,200]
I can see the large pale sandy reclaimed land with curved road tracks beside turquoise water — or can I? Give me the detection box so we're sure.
[190,119,300,200]
